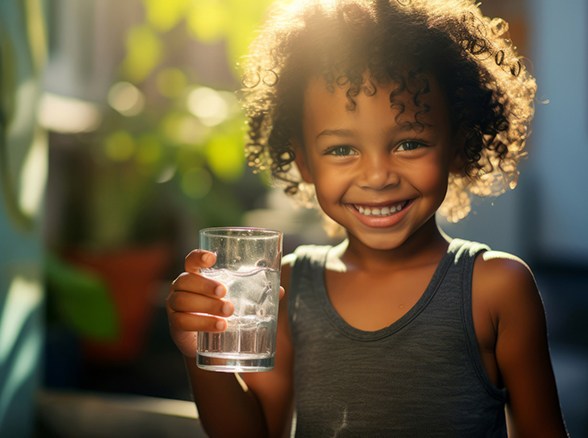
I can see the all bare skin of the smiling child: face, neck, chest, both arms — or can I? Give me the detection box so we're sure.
[167,77,565,437]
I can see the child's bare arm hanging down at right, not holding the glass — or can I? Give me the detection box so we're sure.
[474,252,567,438]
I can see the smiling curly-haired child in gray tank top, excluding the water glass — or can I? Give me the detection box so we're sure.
[168,0,566,437]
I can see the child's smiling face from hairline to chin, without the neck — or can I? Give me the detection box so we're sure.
[296,77,456,249]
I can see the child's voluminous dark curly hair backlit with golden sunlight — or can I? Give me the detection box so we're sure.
[241,0,536,222]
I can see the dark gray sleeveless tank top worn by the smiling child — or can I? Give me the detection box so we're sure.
[288,239,506,438]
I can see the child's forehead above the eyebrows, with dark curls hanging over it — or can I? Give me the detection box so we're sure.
[303,74,449,129]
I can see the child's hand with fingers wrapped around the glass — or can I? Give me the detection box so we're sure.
[166,249,234,358]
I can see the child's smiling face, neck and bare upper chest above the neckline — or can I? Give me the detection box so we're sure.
[288,76,458,336]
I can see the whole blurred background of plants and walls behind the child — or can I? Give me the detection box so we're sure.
[0,0,588,436]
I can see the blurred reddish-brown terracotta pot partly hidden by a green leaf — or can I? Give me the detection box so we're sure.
[67,245,170,364]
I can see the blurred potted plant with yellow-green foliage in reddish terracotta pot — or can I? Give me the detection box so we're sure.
[47,1,274,361]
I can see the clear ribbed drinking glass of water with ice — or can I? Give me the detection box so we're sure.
[196,227,282,372]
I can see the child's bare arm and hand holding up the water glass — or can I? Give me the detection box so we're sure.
[167,250,291,437]
